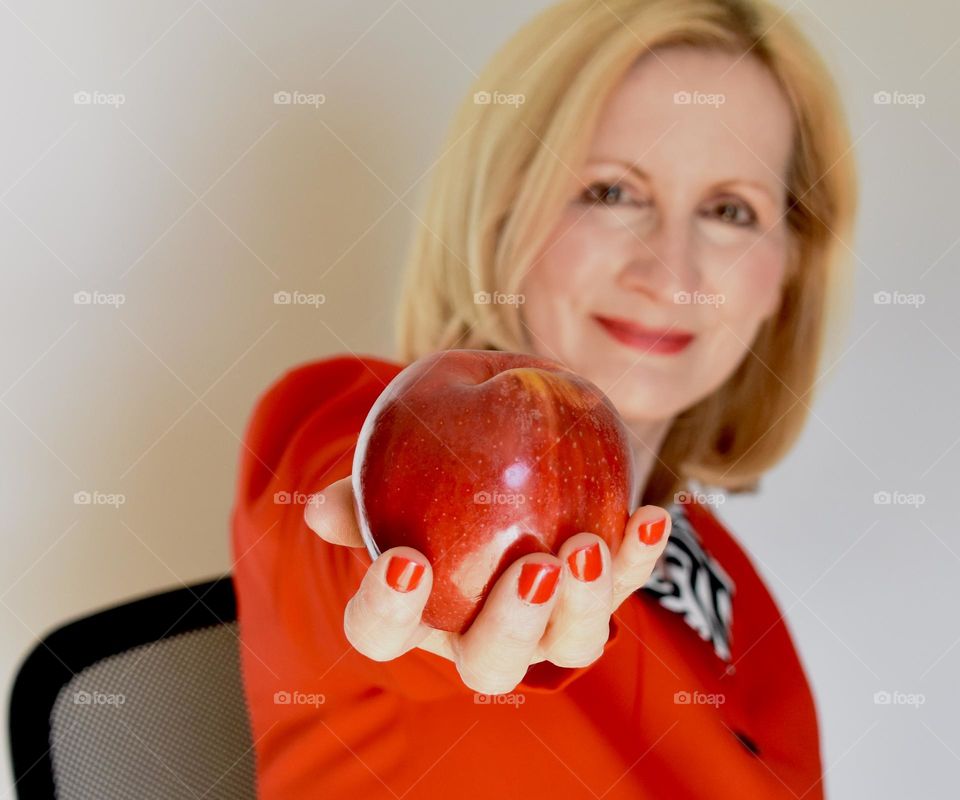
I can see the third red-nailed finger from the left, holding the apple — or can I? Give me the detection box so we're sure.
[540,533,613,667]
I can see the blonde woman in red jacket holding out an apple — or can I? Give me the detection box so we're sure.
[233,0,855,798]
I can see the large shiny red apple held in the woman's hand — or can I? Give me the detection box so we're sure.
[353,350,639,633]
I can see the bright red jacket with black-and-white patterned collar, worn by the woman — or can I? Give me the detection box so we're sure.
[232,356,823,800]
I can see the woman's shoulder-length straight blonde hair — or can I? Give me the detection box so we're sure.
[397,0,857,505]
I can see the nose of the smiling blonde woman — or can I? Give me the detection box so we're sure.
[618,215,700,303]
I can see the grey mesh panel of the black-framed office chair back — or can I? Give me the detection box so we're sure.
[50,622,254,800]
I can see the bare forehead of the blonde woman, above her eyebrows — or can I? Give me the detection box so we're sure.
[590,47,793,187]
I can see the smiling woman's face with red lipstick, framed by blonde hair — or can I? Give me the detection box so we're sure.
[520,48,793,421]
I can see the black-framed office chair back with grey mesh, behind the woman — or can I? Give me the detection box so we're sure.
[4,575,255,800]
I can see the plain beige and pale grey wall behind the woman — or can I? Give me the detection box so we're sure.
[0,0,960,798]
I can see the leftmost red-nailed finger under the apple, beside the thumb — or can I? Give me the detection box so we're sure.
[343,547,433,661]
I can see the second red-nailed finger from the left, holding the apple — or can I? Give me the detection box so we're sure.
[456,553,563,694]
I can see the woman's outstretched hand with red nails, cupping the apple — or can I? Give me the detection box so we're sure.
[304,477,671,694]
